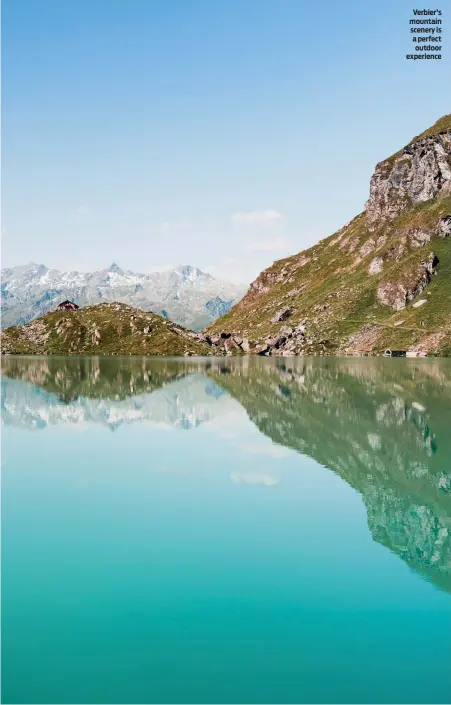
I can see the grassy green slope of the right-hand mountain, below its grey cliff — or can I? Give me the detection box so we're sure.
[208,192,451,354]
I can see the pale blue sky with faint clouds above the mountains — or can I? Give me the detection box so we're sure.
[2,0,451,282]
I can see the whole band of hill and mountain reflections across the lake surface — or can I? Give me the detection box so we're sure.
[2,357,451,592]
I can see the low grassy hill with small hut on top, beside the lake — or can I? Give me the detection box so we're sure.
[1,303,215,355]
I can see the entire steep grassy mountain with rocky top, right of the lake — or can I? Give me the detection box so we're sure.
[206,115,451,355]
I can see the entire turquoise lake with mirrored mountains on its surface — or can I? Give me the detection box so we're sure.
[2,357,451,703]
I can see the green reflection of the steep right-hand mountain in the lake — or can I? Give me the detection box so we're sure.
[210,358,451,592]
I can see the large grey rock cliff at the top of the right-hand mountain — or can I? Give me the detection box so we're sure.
[366,130,451,227]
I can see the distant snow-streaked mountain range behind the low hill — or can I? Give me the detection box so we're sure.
[1,262,245,330]
